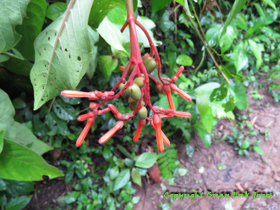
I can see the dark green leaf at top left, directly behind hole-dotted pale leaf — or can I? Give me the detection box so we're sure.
[16,0,47,61]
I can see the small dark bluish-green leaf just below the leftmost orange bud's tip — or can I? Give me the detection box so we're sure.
[53,99,77,120]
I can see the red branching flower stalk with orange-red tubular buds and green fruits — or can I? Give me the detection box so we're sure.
[61,0,191,152]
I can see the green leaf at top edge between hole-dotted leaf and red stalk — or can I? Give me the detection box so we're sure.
[88,0,126,28]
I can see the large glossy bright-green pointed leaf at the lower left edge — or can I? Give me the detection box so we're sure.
[0,139,63,181]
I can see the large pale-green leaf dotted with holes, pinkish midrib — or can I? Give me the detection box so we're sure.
[30,0,93,110]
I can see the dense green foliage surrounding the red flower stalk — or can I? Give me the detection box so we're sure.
[0,0,280,210]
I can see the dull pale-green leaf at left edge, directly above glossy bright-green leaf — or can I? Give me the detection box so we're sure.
[0,89,52,155]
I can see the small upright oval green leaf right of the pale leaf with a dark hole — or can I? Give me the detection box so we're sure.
[233,82,248,110]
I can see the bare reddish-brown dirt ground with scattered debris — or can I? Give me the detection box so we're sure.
[25,84,280,210]
